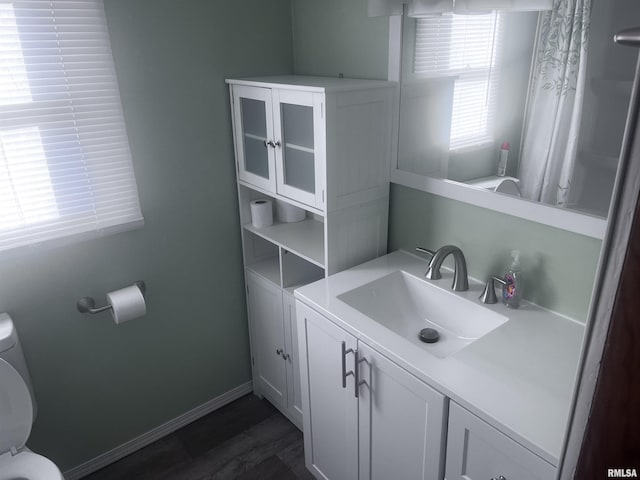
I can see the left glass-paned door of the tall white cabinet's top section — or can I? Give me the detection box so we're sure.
[233,85,276,192]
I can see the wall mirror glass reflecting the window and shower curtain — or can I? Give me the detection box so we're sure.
[398,0,640,217]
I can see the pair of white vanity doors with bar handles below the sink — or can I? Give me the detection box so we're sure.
[296,301,448,480]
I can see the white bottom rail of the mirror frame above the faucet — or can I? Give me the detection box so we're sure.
[391,169,607,240]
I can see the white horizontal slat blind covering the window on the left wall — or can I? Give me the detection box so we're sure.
[0,0,144,255]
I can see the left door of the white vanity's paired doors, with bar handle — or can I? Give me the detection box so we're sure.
[296,301,358,480]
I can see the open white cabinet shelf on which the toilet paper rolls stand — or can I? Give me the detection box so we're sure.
[244,219,324,268]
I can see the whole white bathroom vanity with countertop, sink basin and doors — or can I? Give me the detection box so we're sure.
[295,251,583,480]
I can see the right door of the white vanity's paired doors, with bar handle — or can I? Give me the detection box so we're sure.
[358,341,448,480]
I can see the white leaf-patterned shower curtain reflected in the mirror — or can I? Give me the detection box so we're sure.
[519,0,591,206]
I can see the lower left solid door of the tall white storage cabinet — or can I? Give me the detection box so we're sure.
[247,270,287,409]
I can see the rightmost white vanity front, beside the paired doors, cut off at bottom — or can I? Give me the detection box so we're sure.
[445,402,556,480]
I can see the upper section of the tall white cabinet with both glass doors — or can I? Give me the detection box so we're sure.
[227,75,395,213]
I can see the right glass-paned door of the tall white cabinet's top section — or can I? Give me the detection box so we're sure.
[273,90,324,208]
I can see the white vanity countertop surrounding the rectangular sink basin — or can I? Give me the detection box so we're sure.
[295,251,584,466]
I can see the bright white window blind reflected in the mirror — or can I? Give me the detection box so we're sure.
[414,12,504,150]
